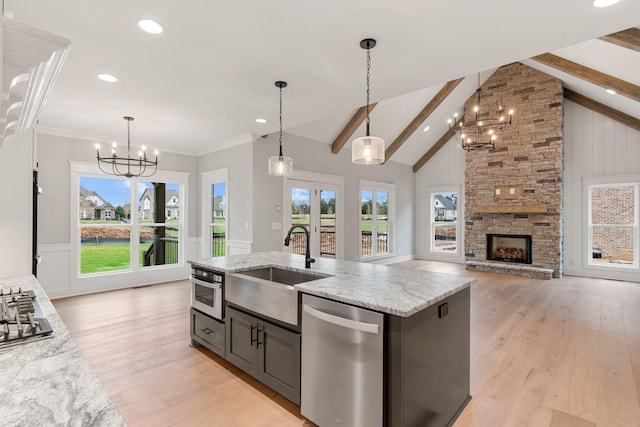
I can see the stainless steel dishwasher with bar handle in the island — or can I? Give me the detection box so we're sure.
[300,295,384,427]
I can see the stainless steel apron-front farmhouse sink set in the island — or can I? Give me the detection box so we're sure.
[224,267,330,326]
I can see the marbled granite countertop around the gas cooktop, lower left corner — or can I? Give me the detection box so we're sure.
[0,276,126,427]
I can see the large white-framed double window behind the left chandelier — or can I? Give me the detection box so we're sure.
[72,163,187,276]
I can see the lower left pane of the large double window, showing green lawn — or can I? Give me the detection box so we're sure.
[80,226,131,274]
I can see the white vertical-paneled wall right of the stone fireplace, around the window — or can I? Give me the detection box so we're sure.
[564,100,640,281]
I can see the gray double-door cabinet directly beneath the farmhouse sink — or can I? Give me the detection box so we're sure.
[226,307,300,404]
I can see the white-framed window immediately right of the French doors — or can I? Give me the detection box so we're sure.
[360,181,395,259]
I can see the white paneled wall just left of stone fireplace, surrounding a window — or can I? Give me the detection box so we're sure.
[415,138,465,263]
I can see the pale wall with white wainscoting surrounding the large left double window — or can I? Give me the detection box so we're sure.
[35,135,200,298]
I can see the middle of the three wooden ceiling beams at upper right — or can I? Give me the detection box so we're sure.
[531,53,640,102]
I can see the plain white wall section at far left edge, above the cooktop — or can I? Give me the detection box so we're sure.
[0,131,33,277]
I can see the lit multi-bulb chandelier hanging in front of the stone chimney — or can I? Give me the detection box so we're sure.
[449,73,513,151]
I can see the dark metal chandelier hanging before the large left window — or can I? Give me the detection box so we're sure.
[96,116,158,178]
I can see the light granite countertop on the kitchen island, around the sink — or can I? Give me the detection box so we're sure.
[189,252,476,317]
